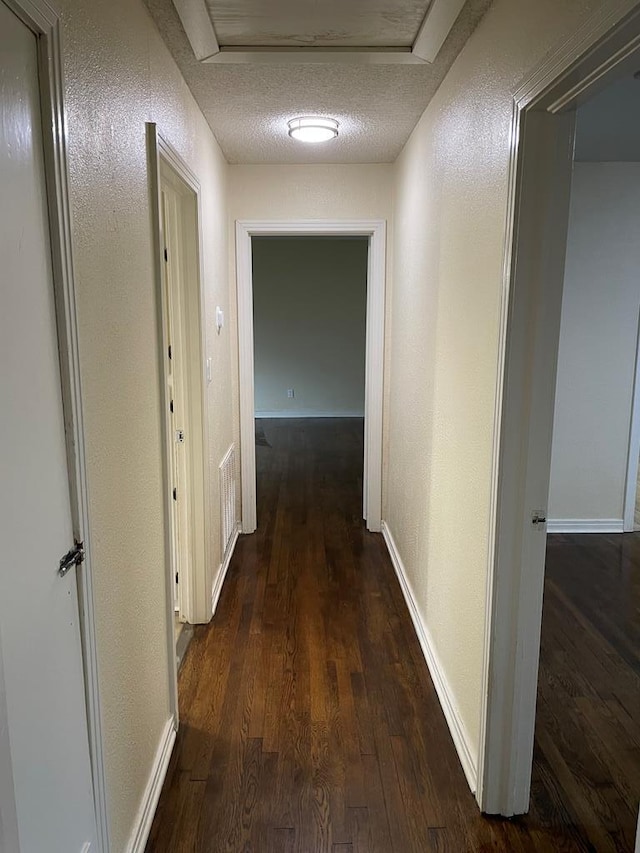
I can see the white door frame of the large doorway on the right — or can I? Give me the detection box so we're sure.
[477,0,640,816]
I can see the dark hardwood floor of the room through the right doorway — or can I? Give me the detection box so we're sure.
[532,533,640,853]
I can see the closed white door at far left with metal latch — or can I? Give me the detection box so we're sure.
[0,2,96,853]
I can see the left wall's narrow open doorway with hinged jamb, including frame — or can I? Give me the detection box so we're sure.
[147,124,211,700]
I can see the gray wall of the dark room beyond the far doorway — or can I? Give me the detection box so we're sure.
[252,237,368,417]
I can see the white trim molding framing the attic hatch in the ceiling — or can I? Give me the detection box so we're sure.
[173,0,465,65]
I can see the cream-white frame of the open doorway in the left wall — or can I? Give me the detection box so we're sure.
[146,122,211,728]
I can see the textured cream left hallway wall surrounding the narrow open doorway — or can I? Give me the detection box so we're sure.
[59,0,232,853]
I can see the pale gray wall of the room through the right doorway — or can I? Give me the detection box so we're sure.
[547,163,640,521]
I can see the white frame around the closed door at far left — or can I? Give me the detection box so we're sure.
[0,0,109,853]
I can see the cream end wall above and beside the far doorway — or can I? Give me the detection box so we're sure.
[228,165,393,502]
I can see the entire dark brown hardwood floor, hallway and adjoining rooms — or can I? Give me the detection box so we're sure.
[147,420,640,853]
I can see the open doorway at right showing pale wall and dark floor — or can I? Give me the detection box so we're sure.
[532,74,640,850]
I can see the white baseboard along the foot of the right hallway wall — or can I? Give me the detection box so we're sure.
[382,521,478,794]
